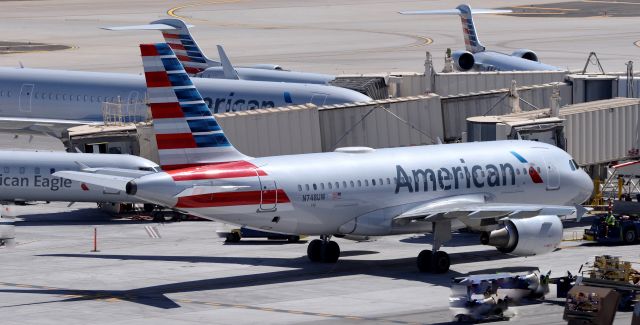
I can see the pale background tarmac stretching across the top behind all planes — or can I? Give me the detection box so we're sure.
[0,0,640,74]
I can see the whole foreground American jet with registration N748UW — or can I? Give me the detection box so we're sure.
[54,43,593,273]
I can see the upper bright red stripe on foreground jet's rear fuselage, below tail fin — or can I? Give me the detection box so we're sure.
[169,160,267,182]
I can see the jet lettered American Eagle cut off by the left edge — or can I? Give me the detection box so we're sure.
[0,150,160,204]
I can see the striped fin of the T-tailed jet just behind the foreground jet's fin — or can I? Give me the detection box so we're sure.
[151,19,220,75]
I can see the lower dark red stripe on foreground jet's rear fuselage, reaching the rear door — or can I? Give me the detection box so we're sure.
[175,189,290,208]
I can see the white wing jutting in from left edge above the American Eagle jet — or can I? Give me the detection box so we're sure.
[0,117,103,138]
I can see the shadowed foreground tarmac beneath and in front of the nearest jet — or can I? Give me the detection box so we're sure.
[0,203,638,324]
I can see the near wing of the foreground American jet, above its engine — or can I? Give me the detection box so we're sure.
[394,194,586,222]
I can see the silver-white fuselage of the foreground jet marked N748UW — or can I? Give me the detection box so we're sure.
[135,141,592,235]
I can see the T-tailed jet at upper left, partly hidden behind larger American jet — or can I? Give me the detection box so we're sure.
[104,18,336,85]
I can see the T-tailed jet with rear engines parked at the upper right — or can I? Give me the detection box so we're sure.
[399,4,564,71]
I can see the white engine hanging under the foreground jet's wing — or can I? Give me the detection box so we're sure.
[480,215,562,256]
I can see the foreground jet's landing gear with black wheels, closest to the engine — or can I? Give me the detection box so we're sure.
[416,220,451,273]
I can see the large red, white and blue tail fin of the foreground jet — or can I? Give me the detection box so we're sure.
[140,43,250,170]
